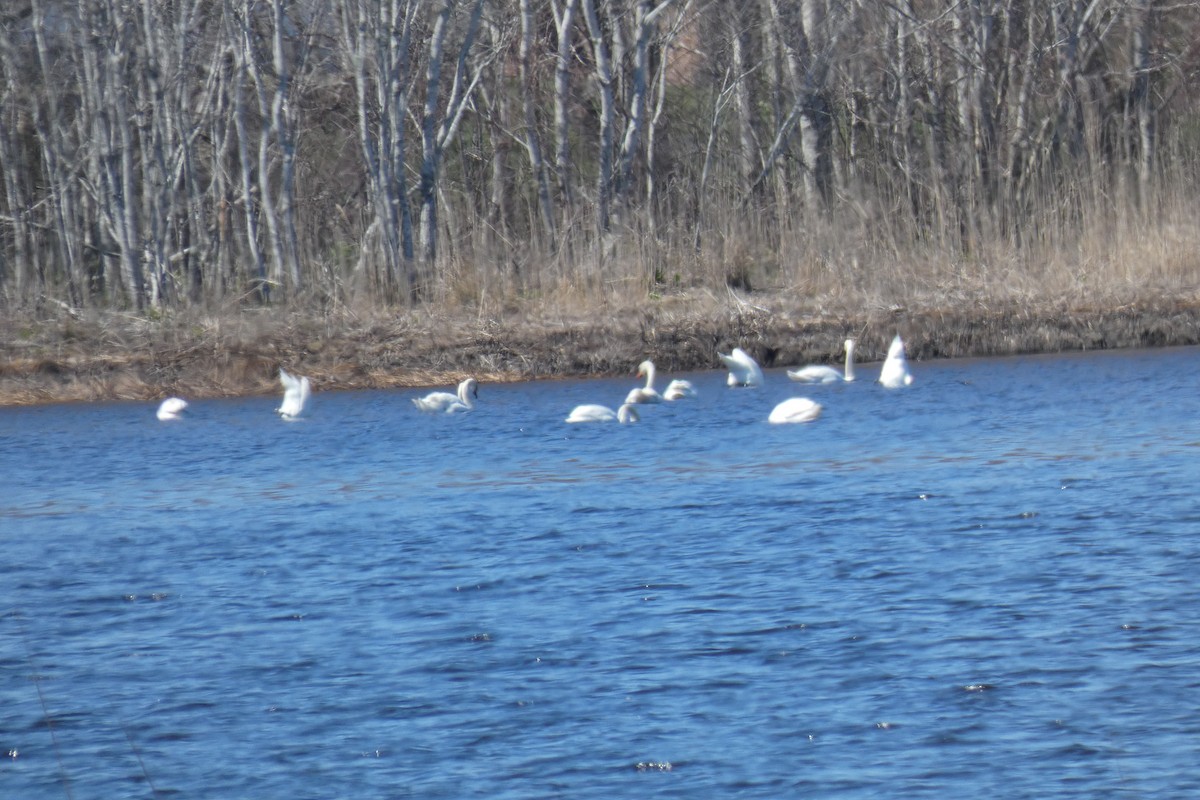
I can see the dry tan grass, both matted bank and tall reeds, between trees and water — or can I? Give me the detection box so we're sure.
[0,181,1200,404]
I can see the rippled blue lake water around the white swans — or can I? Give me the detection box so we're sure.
[0,349,1200,800]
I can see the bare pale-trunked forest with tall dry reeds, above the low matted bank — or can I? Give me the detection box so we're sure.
[0,0,1200,313]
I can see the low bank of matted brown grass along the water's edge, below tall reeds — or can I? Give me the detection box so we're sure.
[0,293,1200,405]
